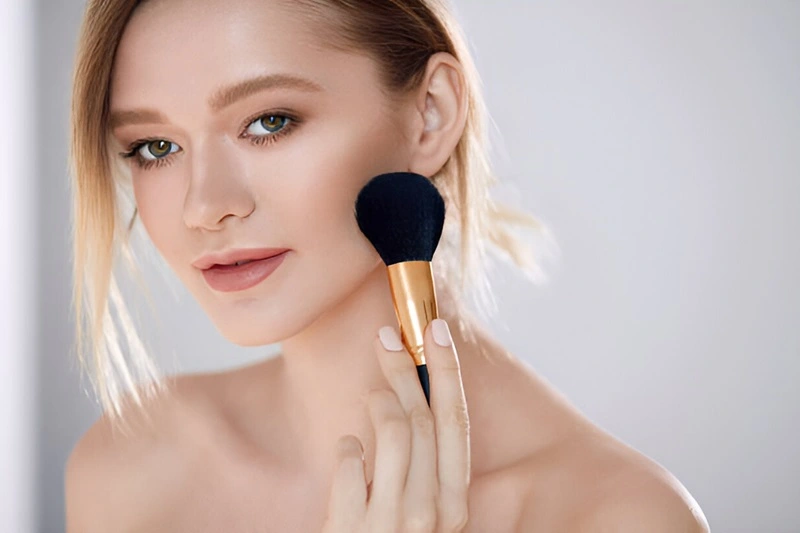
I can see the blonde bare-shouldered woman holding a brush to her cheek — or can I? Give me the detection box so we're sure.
[66,0,707,533]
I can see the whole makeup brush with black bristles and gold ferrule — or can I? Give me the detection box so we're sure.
[355,172,445,405]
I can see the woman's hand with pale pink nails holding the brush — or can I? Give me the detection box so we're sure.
[323,319,470,533]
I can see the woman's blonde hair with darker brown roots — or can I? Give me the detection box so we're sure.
[70,0,547,430]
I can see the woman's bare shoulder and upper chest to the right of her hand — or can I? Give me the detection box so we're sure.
[465,330,709,533]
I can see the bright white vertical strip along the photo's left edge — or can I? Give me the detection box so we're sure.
[0,0,37,533]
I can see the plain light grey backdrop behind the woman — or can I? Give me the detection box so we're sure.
[3,0,800,533]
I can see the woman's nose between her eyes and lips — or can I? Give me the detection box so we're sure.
[183,138,255,231]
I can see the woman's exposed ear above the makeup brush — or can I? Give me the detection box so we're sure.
[408,52,467,177]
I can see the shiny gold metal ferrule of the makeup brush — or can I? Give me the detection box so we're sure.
[388,261,439,366]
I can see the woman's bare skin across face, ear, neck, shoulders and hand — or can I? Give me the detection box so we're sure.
[65,0,707,533]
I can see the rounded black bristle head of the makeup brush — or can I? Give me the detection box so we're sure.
[355,172,445,266]
